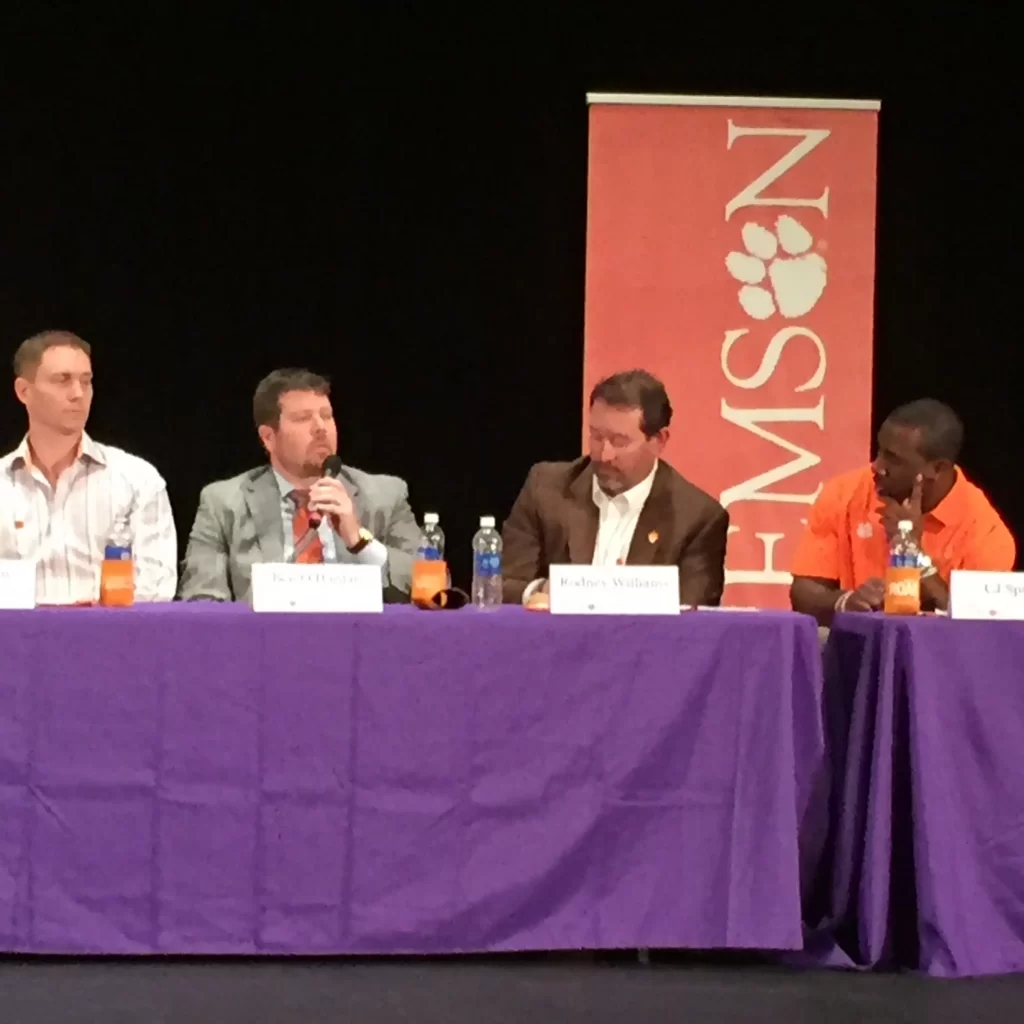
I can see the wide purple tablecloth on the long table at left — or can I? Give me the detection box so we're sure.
[0,604,824,953]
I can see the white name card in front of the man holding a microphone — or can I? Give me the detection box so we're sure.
[253,562,384,612]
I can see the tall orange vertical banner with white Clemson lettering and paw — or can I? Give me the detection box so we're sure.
[584,95,879,607]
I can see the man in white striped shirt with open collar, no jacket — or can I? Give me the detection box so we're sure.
[0,331,177,604]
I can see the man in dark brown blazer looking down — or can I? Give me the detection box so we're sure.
[502,370,729,605]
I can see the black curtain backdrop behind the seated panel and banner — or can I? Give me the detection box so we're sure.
[0,4,1024,584]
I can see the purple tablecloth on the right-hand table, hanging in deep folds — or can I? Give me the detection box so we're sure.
[808,614,1024,977]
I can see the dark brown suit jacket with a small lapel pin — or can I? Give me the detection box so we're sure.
[502,458,729,605]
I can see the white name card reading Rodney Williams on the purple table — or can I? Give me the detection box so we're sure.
[548,565,679,615]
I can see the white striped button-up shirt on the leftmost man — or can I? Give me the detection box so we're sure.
[0,434,178,604]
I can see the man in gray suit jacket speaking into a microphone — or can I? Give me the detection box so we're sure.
[178,370,420,601]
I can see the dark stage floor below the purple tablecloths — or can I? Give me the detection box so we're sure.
[0,954,1024,1024]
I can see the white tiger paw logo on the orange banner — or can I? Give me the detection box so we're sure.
[725,214,828,319]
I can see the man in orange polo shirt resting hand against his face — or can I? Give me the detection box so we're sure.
[790,398,1017,626]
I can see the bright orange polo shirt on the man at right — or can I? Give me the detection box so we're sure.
[791,466,1017,590]
